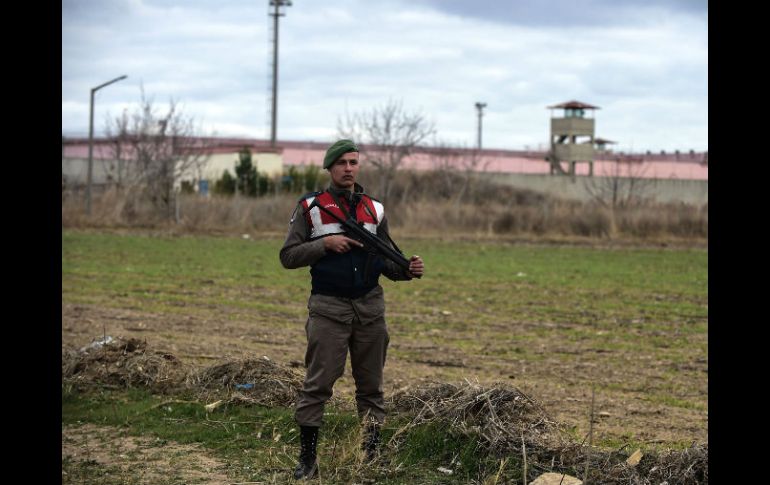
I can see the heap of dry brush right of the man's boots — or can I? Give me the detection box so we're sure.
[392,381,708,485]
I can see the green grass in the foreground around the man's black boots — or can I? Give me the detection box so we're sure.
[62,388,536,484]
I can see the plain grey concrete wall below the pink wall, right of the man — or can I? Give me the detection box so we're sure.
[480,172,708,205]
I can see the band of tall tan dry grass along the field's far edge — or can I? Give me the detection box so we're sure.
[62,172,708,242]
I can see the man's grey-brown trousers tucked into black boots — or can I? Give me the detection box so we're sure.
[294,310,390,426]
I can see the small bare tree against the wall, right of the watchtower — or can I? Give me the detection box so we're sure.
[584,157,652,210]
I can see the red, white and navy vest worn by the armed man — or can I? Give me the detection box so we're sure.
[301,191,385,298]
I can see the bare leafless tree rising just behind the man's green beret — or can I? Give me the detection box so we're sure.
[337,100,435,200]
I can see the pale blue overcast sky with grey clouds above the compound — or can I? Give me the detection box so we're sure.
[62,0,708,151]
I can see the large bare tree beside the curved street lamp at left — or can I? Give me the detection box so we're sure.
[107,89,208,219]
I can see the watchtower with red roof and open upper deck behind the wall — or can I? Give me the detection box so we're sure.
[546,100,599,176]
